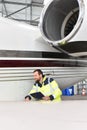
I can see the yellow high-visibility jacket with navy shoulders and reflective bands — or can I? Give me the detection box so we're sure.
[28,76,62,101]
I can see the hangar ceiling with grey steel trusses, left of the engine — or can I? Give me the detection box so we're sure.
[0,0,44,26]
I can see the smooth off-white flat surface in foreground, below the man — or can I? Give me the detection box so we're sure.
[0,100,87,130]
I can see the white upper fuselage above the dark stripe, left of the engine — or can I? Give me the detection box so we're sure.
[0,17,56,51]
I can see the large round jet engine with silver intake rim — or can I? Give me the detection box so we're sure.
[39,0,87,46]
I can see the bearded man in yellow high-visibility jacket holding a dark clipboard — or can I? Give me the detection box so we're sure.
[25,69,62,101]
